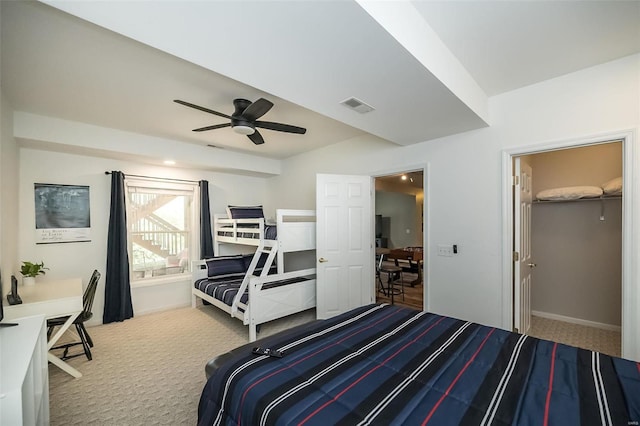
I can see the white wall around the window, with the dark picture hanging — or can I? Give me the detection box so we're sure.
[16,148,266,325]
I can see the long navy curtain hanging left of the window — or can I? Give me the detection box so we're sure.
[102,171,133,324]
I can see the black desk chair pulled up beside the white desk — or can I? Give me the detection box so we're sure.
[47,270,100,361]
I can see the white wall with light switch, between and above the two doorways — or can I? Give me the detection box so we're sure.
[270,55,640,358]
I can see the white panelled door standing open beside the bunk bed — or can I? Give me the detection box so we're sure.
[316,174,374,319]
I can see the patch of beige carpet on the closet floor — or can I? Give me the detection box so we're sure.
[529,316,621,356]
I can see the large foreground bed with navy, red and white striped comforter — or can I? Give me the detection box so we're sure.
[198,305,640,426]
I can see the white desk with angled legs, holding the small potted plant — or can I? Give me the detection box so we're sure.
[4,278,82,377]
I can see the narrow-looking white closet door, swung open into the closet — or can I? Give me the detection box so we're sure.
[513,157,536,334]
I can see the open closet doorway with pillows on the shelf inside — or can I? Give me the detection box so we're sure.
[513,140,624,356]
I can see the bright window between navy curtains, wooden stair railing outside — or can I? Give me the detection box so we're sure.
[126,180,199,281]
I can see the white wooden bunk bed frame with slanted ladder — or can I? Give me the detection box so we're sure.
[192,209,316,342]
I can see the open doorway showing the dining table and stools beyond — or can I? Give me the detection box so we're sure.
[375,169,425,310]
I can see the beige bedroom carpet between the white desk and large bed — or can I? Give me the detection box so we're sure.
[49,306,315,426]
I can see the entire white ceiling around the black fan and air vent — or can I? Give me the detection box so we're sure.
[0,0,640,158]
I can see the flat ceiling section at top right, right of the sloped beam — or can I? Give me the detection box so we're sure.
[414,0,640,96]
